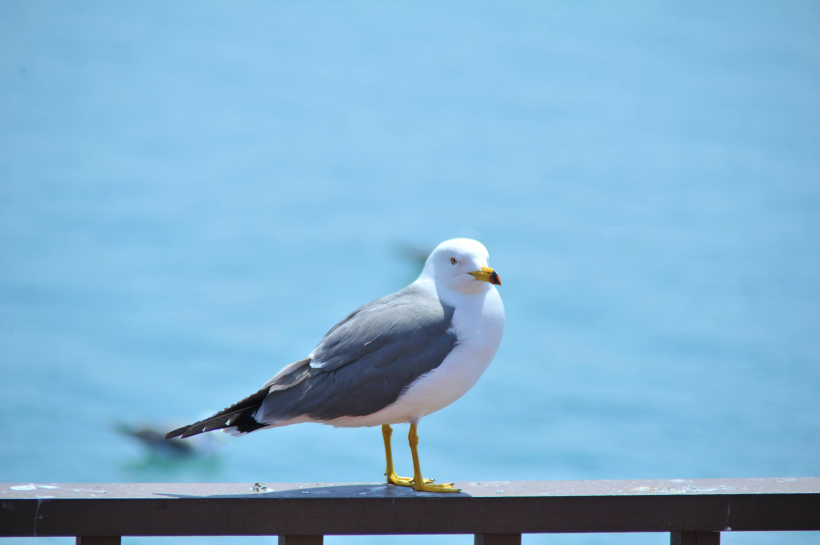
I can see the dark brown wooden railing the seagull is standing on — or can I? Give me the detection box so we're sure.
[0,478,820,545]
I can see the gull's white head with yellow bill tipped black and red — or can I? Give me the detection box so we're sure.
[420,238,501,294]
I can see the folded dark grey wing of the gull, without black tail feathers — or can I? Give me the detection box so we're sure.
[255,285,456,424]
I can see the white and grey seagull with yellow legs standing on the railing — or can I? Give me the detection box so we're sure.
[165,238,504,492]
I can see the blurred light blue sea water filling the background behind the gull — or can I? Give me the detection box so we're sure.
[0,1,820,545]
